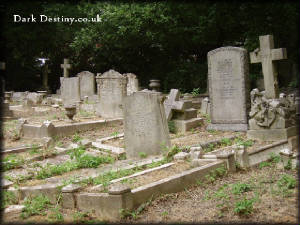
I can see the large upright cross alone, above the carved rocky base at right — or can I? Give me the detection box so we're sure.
[250,35,287,98]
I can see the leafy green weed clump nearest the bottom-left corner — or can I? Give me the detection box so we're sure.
[21,195,50,218]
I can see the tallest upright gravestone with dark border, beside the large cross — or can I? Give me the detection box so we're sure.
[207,47,249,131]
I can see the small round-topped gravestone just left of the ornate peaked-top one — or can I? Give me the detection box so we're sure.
[77,71,95,99]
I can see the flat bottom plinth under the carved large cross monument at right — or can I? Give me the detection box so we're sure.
[247,126,299,141]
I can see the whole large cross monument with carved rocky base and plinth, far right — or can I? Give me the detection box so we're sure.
[247,35,298,141]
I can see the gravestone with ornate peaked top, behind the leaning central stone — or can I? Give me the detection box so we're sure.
[96,70,127,118]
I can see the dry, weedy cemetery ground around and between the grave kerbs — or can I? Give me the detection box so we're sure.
[2,112,297,223]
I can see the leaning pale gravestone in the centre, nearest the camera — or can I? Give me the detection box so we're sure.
[124,91,170,158]
